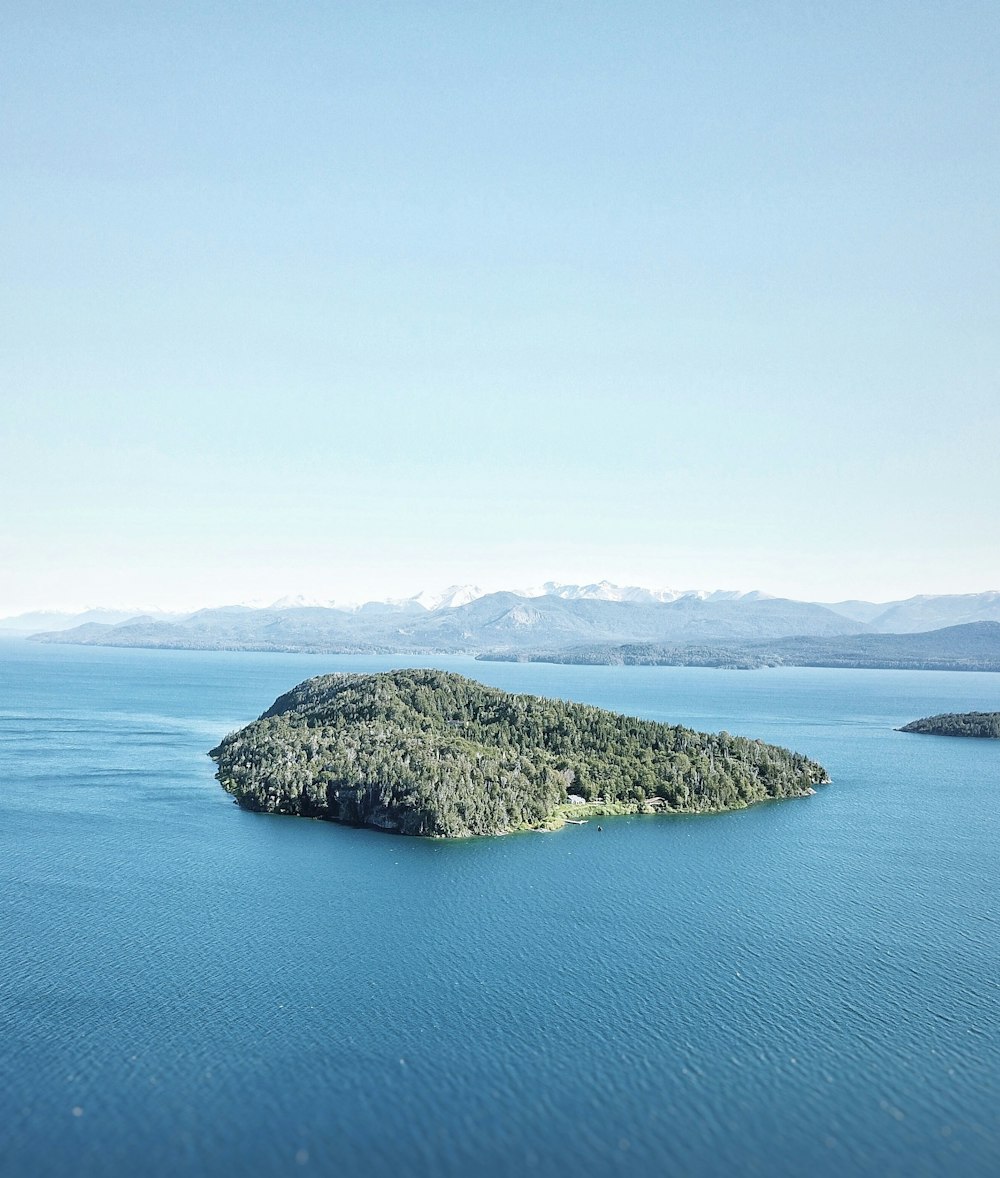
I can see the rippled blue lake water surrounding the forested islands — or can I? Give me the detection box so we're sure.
[0,641,1000,1178]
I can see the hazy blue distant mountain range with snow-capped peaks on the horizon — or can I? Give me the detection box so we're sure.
[9,582,1000,669]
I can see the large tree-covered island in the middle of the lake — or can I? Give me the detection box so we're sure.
[210,670,829,838]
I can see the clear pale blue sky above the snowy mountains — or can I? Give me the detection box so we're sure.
[0,0,1000,614]
